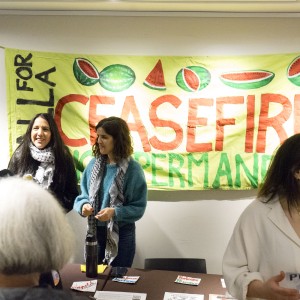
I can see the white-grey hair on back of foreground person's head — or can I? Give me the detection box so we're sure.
[0,177,74,275]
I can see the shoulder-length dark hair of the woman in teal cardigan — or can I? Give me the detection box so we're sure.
[93,117,133,162]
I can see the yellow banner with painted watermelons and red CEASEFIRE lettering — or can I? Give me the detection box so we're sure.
[5,49,300,190]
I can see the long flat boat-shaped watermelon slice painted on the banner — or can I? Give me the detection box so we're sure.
[220,70,275,89]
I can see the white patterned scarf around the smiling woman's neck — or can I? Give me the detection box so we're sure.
[29,144,55,189]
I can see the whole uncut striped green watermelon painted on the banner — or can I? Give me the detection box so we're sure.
[99,64,135,92]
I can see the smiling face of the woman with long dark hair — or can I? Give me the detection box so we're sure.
[31,117,51,149]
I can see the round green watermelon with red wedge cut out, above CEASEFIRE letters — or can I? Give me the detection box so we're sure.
[176,66,211,92]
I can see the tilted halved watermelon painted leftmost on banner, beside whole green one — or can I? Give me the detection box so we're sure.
[73,58,99,86]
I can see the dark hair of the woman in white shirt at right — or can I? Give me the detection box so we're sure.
[258,133,300,210]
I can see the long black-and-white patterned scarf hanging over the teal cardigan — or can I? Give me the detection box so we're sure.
[87,156,129,265]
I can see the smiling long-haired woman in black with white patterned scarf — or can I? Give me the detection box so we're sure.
[8,113,78,212]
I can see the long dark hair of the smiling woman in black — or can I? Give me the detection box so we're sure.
[8,113,71,189]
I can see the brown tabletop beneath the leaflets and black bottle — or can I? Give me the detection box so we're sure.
[60,264,226,300]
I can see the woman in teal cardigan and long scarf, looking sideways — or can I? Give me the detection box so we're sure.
[74,117,147,267]
